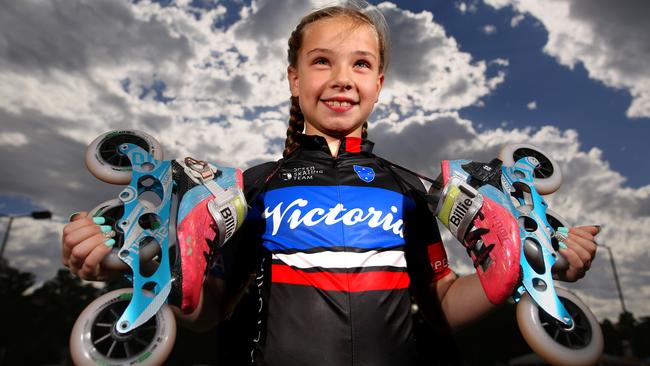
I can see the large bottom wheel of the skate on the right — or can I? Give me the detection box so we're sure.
[517,288,604,365]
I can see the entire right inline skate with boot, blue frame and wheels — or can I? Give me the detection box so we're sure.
[432,144,603,365]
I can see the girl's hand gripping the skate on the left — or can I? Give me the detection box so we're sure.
[61,212,115,281]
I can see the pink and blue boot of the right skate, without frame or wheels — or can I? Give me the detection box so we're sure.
[436,160,520,304]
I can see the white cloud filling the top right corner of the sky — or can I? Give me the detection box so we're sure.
[484,0,650,118]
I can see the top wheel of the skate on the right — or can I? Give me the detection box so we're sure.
[499,144,562,194]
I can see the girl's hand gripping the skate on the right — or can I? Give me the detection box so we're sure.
[557,226,600,282]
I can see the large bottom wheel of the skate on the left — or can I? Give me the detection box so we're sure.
[70,289,176,366]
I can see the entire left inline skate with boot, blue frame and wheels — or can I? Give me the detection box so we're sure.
[70,130,247,365]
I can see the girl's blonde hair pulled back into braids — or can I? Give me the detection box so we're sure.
[282,1,390,157]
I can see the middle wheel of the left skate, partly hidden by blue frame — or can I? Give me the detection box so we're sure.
[90,198,160,271]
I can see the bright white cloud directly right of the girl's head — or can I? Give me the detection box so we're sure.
[379,3,505,114]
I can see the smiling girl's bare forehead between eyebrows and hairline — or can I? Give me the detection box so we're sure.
[301,16,379,56]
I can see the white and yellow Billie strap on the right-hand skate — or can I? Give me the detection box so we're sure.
[437,176,483,243]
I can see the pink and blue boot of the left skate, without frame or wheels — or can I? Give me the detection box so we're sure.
[169,158,247,314]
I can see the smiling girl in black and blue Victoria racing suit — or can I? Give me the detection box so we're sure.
[63,6,597,365]
